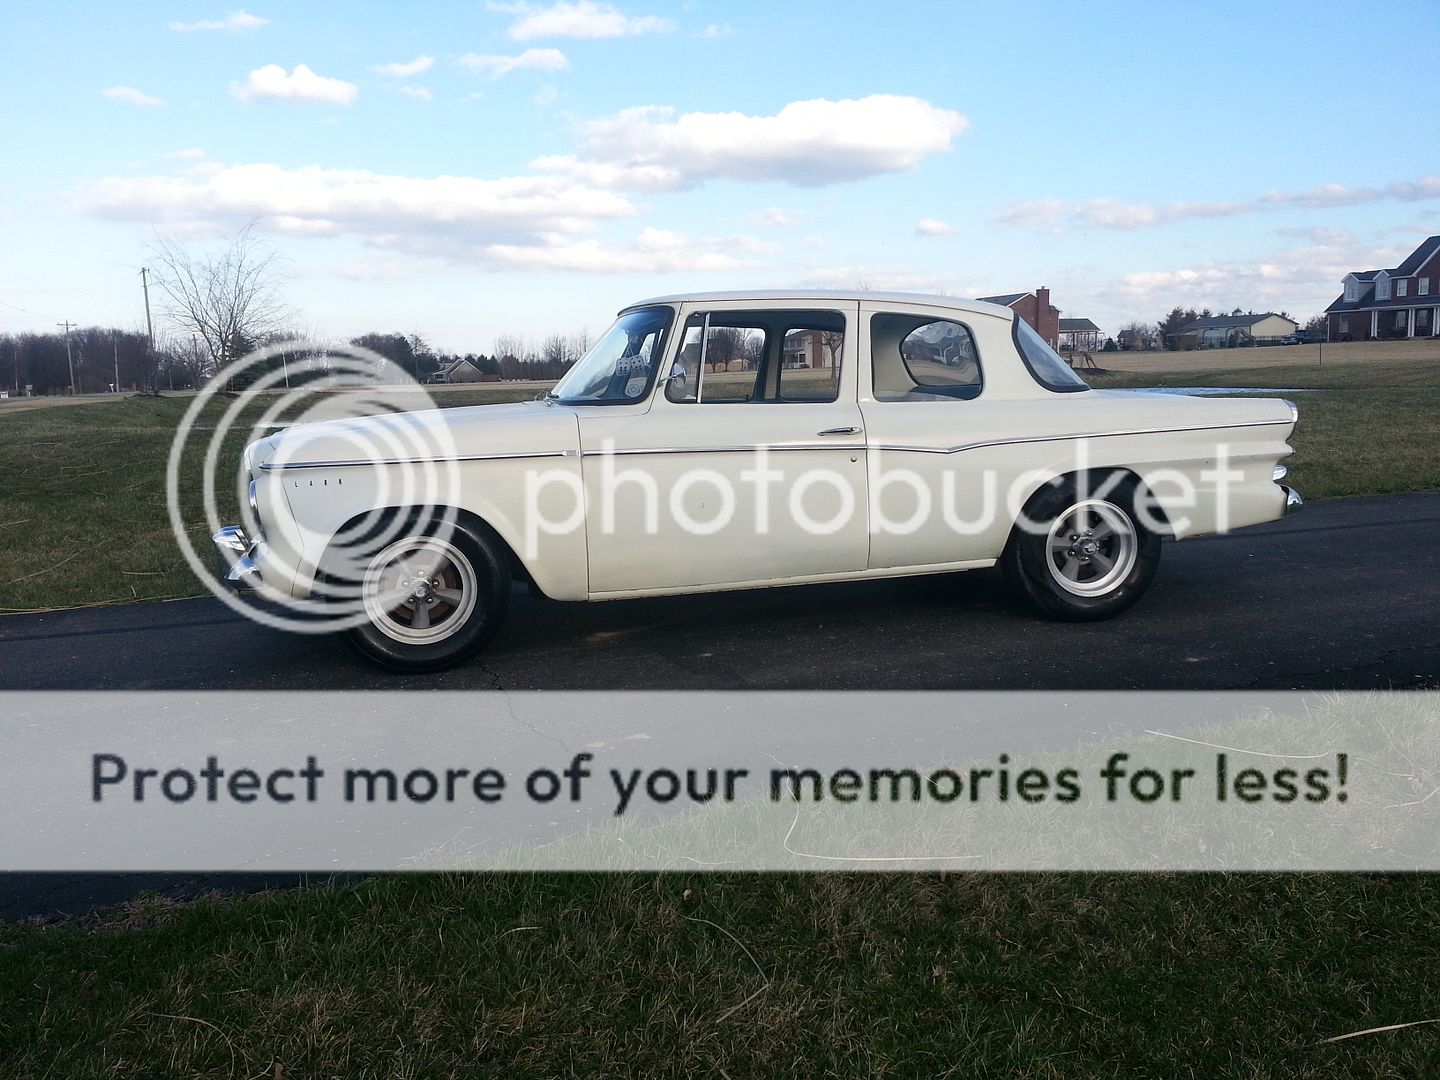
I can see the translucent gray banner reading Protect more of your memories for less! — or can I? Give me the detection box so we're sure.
[0,691,1440,871]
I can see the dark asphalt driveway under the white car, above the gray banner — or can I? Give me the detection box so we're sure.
[0,491,1440,690]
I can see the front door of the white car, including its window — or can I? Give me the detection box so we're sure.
[579,301,868,596]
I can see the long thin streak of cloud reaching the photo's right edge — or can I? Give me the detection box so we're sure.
[991,176,1440,232]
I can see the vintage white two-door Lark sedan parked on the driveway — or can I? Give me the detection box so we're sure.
[215,291,1300,671]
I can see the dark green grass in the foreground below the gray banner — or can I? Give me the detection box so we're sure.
[8,874,1440,1079]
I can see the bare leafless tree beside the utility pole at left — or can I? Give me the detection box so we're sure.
[151,220,287,384]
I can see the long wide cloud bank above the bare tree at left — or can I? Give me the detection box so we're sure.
[71,163,635,253]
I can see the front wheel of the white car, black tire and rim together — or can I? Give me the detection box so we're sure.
[344,518,510,672]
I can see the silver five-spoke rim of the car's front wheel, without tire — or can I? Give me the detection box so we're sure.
[361,536,480,645]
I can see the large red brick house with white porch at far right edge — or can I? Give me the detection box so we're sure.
[1325,236,1440,341]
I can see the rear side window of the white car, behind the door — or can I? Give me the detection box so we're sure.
[870,314,984,402]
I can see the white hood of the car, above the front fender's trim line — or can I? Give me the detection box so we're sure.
[246,402,580,468]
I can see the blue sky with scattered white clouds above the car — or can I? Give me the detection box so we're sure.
[0,0,1440,353]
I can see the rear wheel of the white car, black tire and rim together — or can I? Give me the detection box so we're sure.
[1001,475,1161,622]
